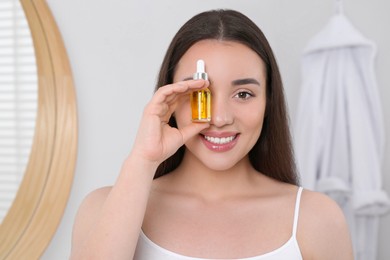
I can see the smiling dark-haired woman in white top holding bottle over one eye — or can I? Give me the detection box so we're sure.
[71,10,353,260]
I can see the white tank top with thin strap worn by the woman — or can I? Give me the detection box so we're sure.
[133,187,303,260]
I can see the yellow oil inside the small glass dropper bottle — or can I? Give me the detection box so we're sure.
[190,88,211,122]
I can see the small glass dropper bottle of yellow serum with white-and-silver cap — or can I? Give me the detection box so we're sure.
[190,60,211,122]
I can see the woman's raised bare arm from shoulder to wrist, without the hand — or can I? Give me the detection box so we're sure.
[71,157,156,259]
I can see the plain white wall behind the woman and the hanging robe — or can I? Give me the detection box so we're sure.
[42,0,390,260]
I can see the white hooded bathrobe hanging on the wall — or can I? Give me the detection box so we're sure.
[293,13,390,260]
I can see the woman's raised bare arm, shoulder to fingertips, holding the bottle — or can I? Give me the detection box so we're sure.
[71,80,208,260]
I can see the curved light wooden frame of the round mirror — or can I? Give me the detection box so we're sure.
[0,0,77,259]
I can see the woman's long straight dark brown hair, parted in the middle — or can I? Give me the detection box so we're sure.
[155,10,298,184]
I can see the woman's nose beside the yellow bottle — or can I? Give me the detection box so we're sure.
[210,96,234,127]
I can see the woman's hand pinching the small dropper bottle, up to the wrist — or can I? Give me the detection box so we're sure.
[132,80,209,164]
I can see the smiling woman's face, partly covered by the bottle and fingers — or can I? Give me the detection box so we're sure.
[174,40,266,170]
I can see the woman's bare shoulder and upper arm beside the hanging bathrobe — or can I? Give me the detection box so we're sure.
[297,189,353,259]
